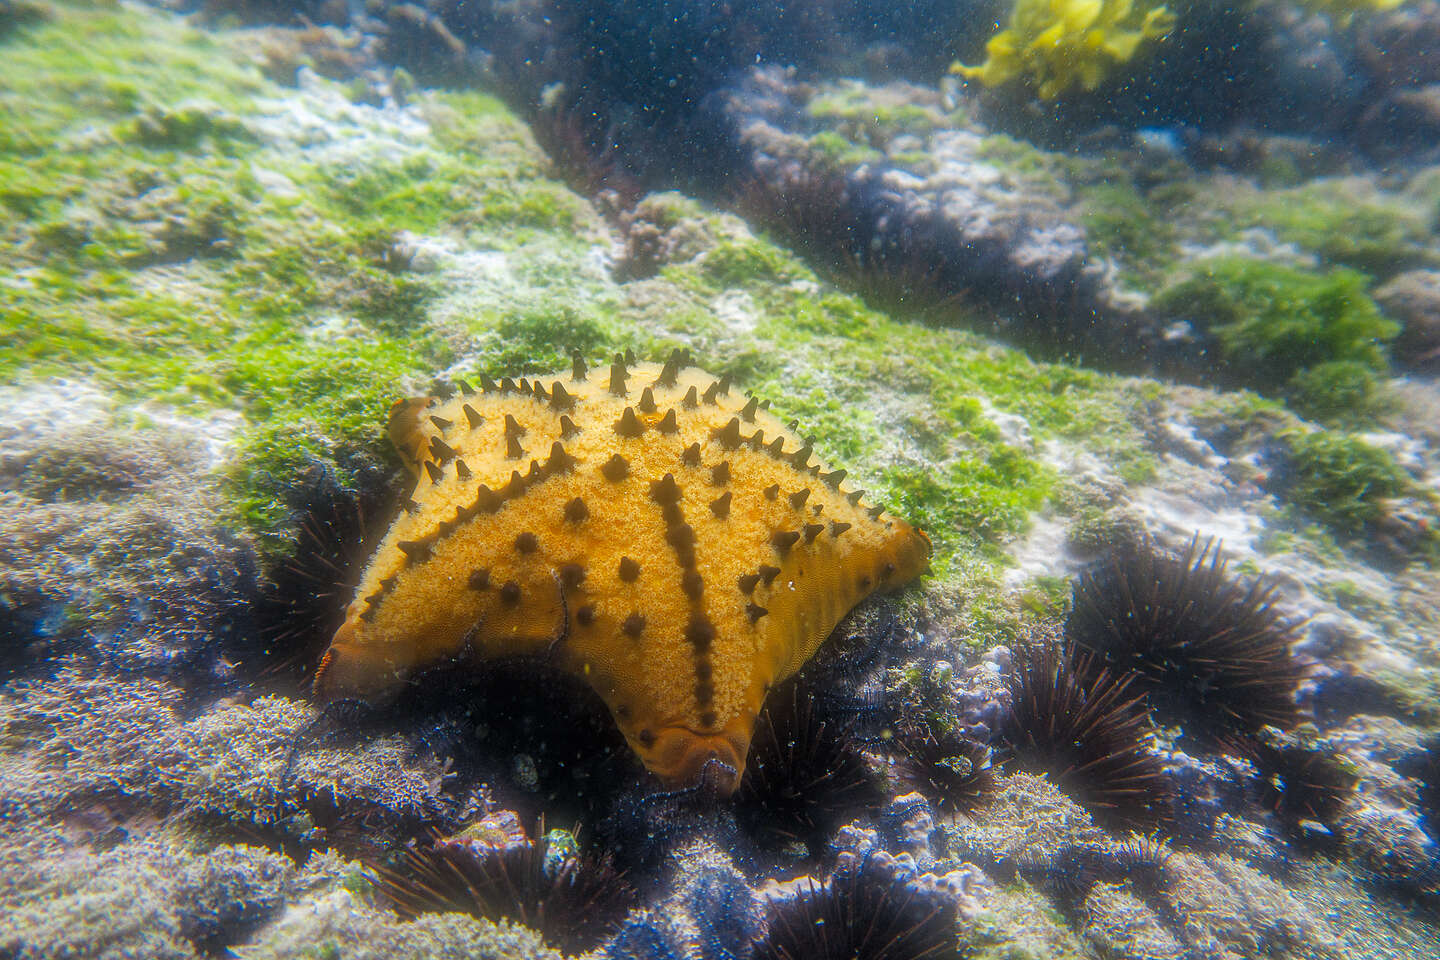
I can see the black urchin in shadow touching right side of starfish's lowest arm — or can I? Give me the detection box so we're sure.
[736,684,880,853]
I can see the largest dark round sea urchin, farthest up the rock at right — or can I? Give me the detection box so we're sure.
[1066,535,1305,740]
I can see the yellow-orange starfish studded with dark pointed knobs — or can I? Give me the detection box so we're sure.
[315,351,930,794]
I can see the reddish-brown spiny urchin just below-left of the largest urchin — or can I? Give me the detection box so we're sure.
[1009,642,1171,828]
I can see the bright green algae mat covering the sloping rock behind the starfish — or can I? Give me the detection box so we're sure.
[0,7,1153,584]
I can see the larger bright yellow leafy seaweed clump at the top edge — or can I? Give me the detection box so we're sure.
[950,0,1175,99]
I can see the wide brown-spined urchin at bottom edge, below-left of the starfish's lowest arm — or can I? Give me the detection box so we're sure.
[379,825,636,953]
